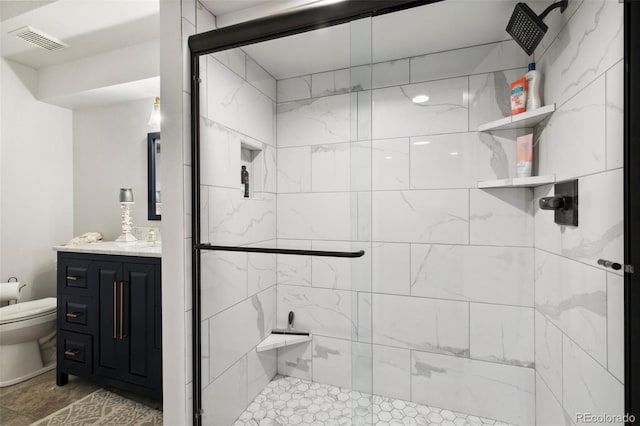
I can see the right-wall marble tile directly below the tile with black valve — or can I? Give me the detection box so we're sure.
[536,250,607,365]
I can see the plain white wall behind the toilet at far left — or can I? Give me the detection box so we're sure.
[0,59,73,300]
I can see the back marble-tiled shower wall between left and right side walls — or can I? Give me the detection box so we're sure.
[276,42,535,424]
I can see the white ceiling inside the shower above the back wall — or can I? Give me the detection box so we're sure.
[243,0,540,79]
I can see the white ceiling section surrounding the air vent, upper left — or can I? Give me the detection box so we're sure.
[0,0,160,69]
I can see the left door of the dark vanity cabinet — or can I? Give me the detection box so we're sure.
[95,261,124,378]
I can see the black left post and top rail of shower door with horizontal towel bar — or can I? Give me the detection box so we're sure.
[189,0,443,426]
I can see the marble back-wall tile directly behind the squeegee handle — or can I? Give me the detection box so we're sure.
[277,285,356,339]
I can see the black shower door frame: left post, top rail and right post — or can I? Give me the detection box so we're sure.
[189,0,640,426]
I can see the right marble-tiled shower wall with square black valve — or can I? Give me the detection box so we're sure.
[533,0,624,425]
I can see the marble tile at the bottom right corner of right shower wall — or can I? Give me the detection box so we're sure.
[562,337,624,425]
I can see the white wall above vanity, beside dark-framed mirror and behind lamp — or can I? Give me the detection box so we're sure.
[73,98,161,242]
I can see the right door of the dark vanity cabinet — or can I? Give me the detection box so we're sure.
[121,263,159,387]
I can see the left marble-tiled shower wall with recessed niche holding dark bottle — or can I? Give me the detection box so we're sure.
[200,41,278,425]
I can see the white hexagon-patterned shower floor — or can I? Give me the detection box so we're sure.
[234,376,511,426]
